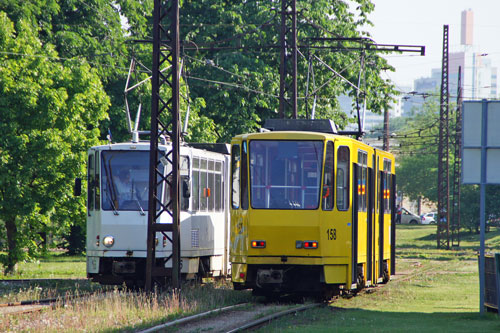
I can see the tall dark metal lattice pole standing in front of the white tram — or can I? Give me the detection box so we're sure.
[145,0,180,291]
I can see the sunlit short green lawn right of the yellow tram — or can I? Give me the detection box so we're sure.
[261,225,500,332]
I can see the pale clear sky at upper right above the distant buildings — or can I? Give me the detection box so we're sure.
[366,0,500,90]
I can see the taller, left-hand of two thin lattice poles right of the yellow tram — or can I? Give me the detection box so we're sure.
[437,25,450,249]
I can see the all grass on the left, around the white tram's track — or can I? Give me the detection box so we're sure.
[0,253,251,332]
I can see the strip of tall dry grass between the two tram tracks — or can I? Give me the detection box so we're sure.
[0,281,251,332]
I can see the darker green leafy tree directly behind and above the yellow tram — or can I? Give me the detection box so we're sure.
[180,0,394,142]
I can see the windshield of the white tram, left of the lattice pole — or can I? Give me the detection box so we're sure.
[101,151,149,212]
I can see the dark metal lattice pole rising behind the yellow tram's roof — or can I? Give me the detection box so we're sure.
[279,0,297,119]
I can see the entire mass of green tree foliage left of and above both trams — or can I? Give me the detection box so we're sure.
[0,0,394,269]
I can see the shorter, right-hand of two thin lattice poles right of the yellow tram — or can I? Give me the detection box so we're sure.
[450,67,462,247]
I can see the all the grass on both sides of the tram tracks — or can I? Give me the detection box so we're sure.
[0,225,500,332]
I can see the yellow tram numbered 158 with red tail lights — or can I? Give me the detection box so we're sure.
[230,120,395,297]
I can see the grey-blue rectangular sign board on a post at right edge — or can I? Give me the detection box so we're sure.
[462,100,500,184]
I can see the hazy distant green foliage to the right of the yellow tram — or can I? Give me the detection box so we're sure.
[397,92,500,232]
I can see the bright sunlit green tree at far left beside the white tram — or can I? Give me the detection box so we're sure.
[0,12,109,272]
